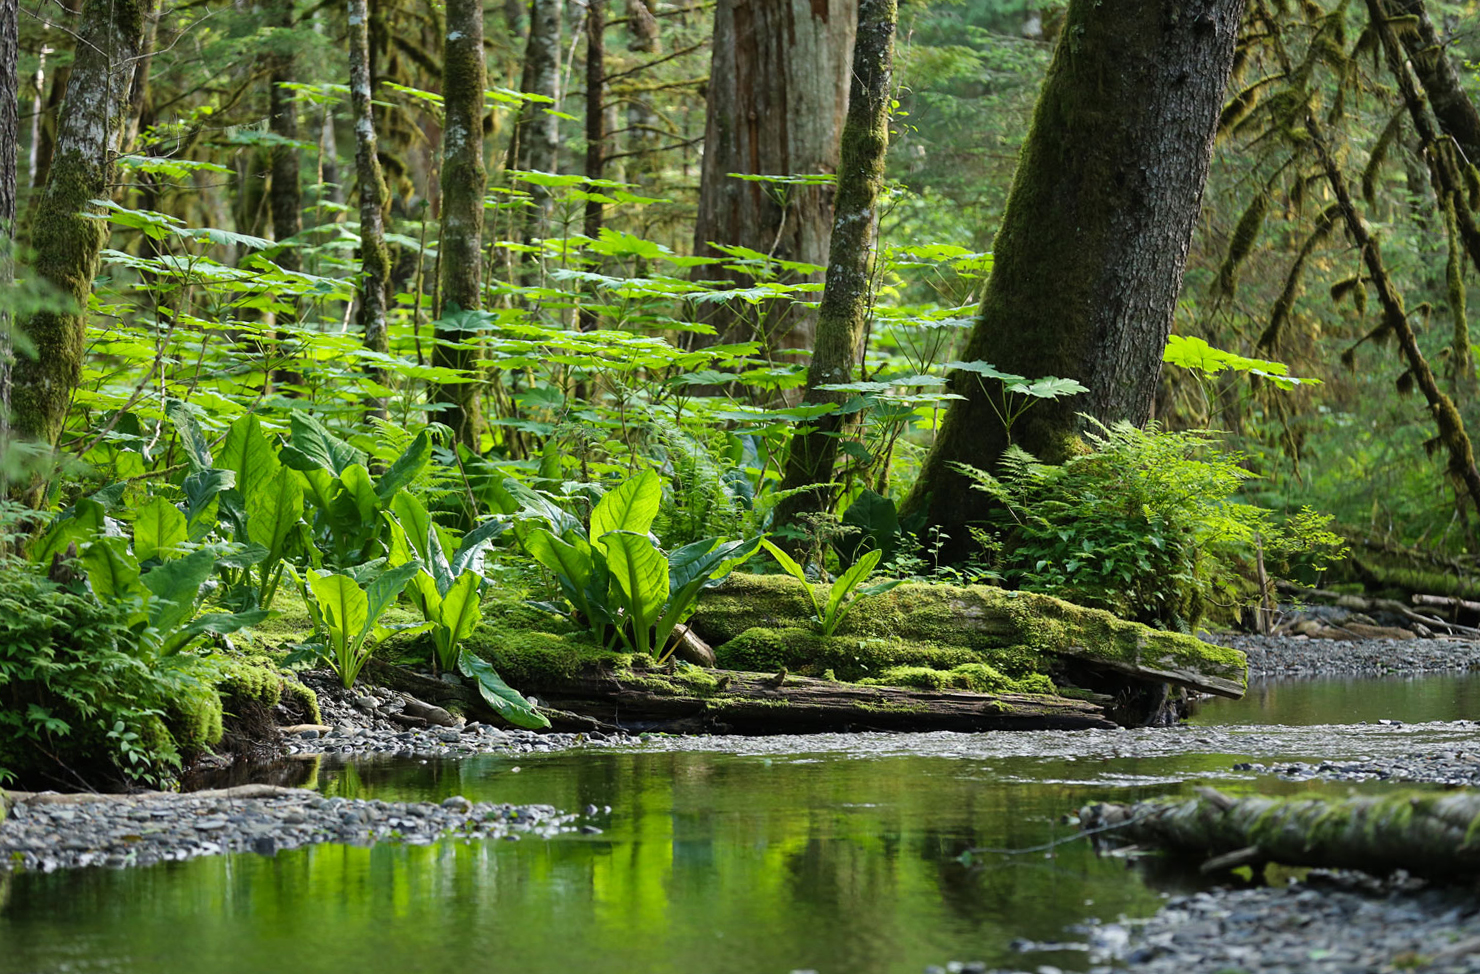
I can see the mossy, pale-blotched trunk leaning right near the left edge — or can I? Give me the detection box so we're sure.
[12,0,154,470]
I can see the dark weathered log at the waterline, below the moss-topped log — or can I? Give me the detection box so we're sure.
[509,669,1114,734]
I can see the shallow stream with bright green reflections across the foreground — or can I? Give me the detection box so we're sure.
[0,674,1480,974]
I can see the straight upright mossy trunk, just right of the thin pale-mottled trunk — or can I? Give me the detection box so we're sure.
[432,0,485,450]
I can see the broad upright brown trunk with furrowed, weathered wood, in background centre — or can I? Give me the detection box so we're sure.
[694,0,858,351]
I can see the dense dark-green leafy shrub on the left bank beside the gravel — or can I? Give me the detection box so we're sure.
[0,562,221,787]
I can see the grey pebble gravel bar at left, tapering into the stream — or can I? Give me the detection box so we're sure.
[0,786,599,872]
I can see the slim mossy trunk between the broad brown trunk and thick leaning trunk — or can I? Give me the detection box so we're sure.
[776,0,898,527]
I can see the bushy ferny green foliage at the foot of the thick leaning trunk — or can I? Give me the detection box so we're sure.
[961,423,1341,632]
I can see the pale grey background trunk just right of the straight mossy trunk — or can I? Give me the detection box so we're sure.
[508,0,564,243]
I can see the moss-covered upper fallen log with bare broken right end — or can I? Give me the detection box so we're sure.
[690,574,1248,697]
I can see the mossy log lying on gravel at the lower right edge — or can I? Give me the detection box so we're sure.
[1079,787,1480,881]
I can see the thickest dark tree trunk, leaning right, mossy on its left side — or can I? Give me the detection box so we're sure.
[906,0,1243,558]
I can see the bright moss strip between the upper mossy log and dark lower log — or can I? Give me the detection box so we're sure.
[715,629,981,682]
